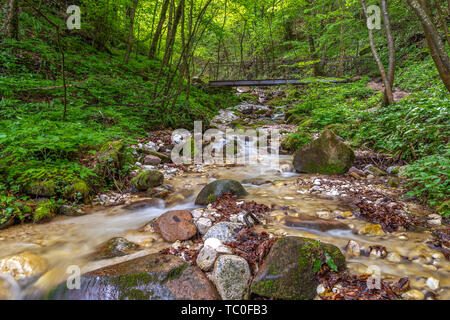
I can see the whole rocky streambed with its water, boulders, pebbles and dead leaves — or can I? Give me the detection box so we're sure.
[0,90,450,299]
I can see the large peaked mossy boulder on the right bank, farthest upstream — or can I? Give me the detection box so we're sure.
[294,130,355,174]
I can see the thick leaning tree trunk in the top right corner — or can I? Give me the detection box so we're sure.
[406,0,450,92]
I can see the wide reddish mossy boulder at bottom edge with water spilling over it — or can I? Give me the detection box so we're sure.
[46,253,219,300]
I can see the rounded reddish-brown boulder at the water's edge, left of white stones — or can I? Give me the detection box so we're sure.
[154,210,197,242]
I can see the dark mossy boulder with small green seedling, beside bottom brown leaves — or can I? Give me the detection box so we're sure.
[251,237,345,300]
